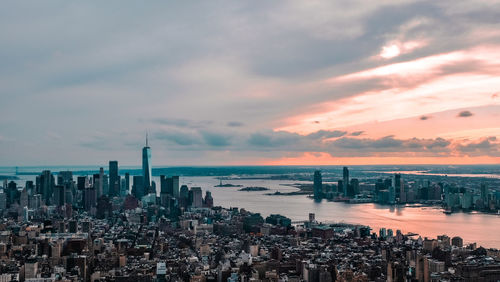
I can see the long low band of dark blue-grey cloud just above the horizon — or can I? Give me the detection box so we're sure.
[155,124,498,157]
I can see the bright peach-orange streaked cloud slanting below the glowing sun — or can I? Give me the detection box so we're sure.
[276,46,500,134]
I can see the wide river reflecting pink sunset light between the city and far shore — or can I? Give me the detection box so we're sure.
[172,177,500,248]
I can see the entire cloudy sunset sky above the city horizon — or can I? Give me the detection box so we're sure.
[0,0,500,166]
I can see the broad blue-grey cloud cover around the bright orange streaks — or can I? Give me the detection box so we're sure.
[0,0,500,165]
